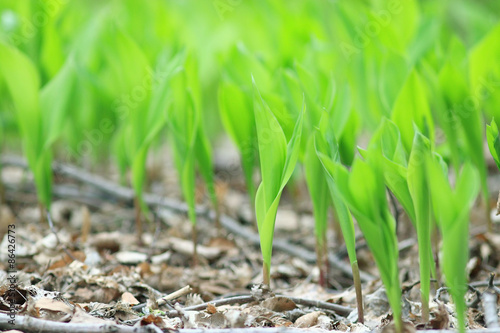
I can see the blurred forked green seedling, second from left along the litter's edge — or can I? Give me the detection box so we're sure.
[106,31,181,243]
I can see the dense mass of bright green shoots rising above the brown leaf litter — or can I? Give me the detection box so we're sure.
[0,0,500,328]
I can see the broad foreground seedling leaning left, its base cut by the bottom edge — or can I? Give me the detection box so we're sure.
[333,158,403,332]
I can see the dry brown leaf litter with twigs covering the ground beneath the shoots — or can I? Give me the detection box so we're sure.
[0,150,500,332]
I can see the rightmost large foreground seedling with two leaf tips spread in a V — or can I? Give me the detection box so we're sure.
[427,158,480,332]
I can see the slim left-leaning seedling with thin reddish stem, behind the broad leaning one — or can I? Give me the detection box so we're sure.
[309,113,364,323]
